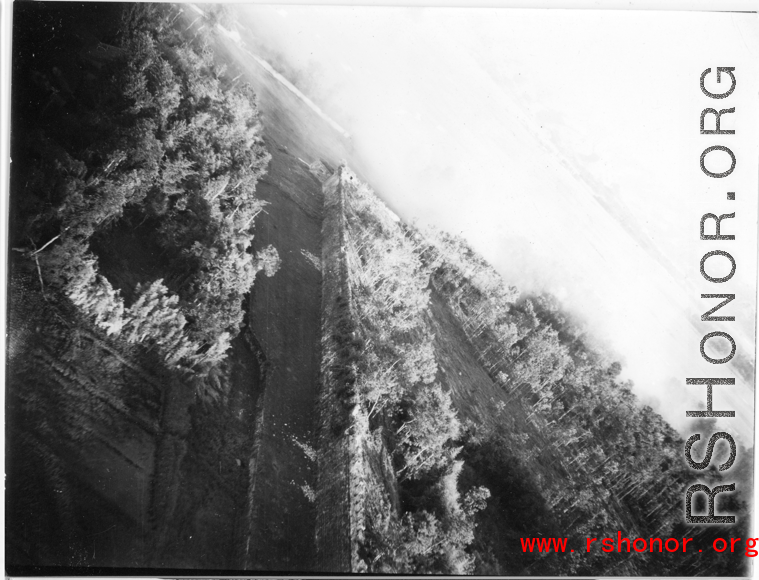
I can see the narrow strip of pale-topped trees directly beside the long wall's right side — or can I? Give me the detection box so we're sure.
[336,168,490,574]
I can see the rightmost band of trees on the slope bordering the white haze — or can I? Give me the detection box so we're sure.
[416,230,750,575]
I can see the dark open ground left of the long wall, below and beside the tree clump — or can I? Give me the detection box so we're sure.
[6,5,342,573]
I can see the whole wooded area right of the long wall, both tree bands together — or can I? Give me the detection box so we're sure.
[334,168,748,575]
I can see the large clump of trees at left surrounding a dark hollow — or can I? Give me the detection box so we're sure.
[13,4,279,390]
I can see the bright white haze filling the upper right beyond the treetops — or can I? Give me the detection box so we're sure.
[227,5,759,445]
